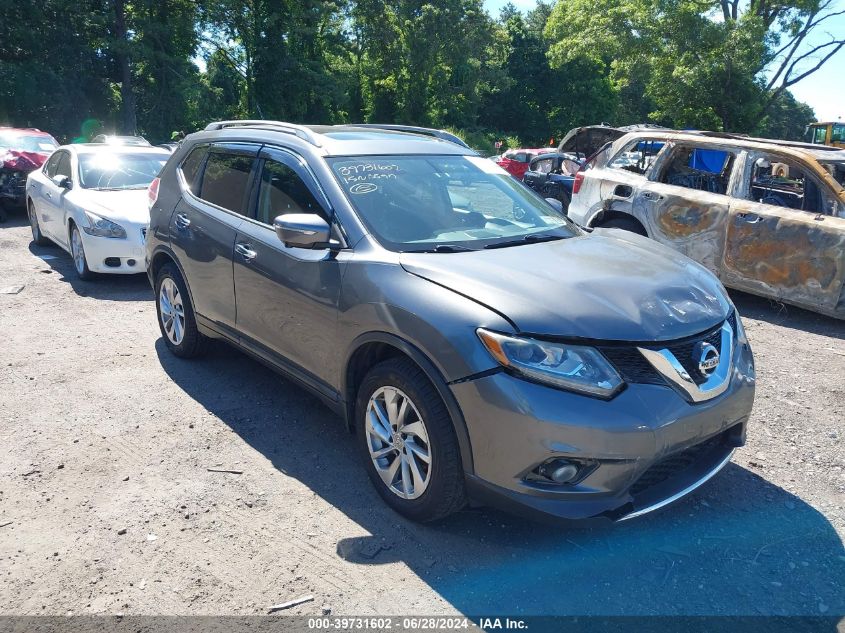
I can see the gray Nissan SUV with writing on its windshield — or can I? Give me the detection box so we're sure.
[146,121,755,521]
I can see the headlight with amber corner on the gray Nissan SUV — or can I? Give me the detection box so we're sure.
[476,328,624,398]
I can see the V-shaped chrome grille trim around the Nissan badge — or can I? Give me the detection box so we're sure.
[637,321,734,403]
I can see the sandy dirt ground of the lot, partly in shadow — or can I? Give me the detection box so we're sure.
[0,211,845,616]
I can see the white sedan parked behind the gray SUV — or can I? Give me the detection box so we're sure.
[26,144,170,279]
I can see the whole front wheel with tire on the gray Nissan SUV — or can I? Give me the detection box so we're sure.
[355,358,466,521]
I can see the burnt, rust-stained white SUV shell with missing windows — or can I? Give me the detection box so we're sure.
[569,131,845,318]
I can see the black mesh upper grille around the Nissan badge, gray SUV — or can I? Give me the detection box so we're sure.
[599,312,737,385]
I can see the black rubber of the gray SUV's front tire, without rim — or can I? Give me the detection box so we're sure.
[355,357,466,521]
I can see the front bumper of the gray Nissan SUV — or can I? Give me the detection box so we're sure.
[452,336,755,521]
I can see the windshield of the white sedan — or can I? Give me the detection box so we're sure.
[79,152,169,189]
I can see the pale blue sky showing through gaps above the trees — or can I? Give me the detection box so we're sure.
[484,0,845,121]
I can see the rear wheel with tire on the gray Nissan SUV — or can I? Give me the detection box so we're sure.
[155,263,207,358]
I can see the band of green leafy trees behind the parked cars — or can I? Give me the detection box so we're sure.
[0,0,838,144]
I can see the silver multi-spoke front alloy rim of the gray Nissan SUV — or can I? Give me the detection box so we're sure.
[364,387,432,499]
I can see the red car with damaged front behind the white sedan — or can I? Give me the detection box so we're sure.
[0,127,59,219]
